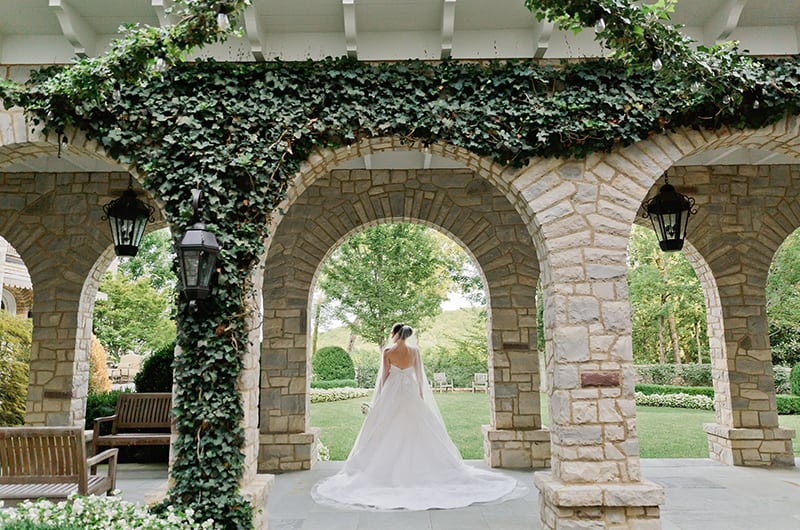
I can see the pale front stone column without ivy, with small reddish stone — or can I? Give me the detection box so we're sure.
[520,155,664,529]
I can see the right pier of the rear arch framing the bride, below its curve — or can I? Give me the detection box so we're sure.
[483,302,550,469]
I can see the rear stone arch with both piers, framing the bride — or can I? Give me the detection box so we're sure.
[259,163,548,470]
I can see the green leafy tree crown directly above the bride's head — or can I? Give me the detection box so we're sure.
[319,223,463,347]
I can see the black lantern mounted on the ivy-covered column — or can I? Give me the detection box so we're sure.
[178,190,219,301]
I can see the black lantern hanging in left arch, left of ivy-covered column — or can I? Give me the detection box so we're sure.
[103,177,155,256]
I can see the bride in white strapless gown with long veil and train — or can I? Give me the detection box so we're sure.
[311,324,527,510]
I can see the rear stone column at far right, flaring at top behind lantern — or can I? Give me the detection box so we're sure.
[670,166,800,466]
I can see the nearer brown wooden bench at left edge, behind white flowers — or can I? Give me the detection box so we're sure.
[0,427,118,506]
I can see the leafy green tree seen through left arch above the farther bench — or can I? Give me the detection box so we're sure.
[94,271,175,360]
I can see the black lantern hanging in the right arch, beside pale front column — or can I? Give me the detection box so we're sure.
[643,175,697,252]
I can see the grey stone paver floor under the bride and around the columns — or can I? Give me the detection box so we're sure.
[111,459,800,530]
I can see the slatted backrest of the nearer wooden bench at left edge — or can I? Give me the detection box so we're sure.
[0,427,86,484]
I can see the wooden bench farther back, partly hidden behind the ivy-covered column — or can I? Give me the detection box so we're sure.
[92,392,172,454]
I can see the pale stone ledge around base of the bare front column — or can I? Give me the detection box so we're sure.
[533,471,665,508]
